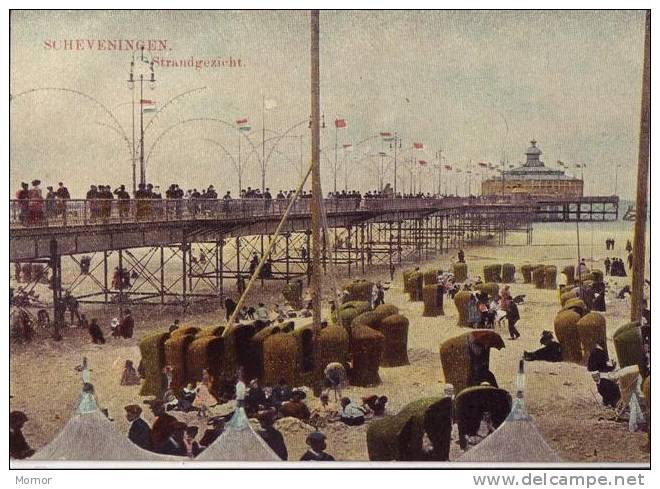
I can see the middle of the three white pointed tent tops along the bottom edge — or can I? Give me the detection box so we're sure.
[195,407,281,462]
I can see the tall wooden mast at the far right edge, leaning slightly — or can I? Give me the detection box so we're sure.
[630,10,651,321]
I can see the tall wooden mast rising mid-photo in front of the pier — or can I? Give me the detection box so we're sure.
[310,10,323,331]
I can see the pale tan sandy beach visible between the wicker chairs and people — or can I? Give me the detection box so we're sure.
[10,222,650,463]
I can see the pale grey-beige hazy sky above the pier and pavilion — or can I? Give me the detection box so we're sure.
[10,11,644,199]
